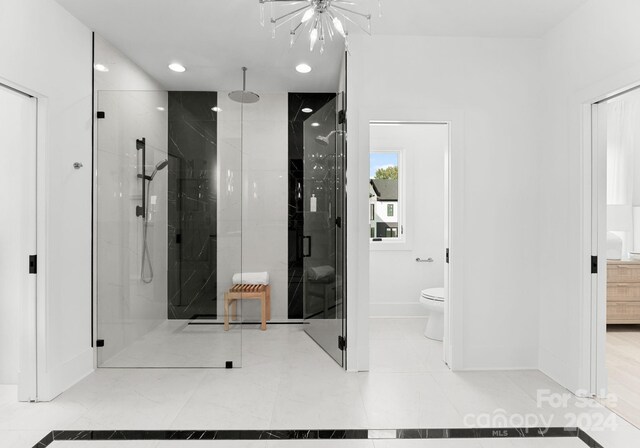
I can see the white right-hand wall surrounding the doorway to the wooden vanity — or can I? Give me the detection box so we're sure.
[537,0,640,391]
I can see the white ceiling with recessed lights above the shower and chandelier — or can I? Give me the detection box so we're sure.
[57,0,586,92]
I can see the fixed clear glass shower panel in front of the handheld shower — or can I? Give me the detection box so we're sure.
[94,91,242,368]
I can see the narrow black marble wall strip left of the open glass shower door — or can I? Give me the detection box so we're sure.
[288,93,336,319]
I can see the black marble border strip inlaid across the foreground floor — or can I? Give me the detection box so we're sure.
[34,428,604,448]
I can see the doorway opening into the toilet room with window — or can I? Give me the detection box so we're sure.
[368,121,450,372]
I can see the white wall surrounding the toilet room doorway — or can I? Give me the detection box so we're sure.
[348,36,542,369]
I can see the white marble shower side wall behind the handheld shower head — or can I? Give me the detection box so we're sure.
[96,91,168,365]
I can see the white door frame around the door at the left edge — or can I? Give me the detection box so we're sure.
[0,78,40,401]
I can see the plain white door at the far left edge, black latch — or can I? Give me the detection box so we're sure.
[0,85,37,401]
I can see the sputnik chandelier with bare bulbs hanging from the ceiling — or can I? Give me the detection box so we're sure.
[258,0,382,53]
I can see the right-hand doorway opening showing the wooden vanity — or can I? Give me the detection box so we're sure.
[591,85,640,427]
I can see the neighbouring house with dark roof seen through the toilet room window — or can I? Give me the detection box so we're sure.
[369,179,398,238]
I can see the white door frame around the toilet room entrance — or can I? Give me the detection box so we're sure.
[347,108,465,371]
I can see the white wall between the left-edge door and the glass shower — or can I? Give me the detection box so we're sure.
[0,0,93,400]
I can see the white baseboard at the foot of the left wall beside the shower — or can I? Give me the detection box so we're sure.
[38,347,93,401]
